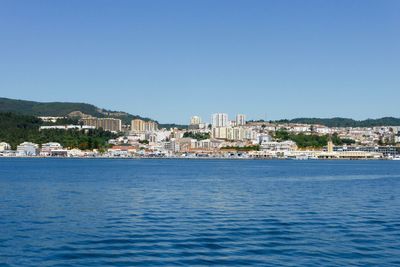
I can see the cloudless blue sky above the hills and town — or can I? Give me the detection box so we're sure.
[0,0,400,123]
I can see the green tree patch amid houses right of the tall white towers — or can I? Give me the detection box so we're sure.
[274,129,354,148]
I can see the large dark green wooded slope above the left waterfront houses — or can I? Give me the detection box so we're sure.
[0,112,117,149]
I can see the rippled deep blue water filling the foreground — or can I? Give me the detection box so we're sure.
[0,159,400,266]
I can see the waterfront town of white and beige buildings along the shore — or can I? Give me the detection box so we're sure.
[0,113,400,159]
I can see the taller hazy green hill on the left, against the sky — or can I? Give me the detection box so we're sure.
[0,98,151,124]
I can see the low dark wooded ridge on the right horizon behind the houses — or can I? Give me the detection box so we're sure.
[275,117,400,127]
